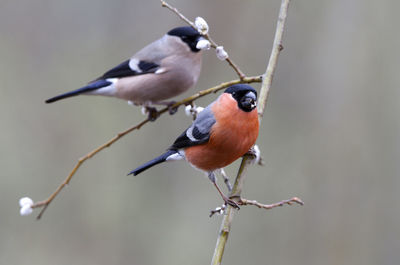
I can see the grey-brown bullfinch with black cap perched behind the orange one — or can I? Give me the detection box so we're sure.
[46,27,204,118]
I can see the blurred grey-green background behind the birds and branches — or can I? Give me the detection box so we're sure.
[0,0,400,265]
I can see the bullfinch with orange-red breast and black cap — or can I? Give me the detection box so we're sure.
[128,84,259,208]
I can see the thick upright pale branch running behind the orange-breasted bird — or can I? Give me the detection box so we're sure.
[211,0,290,265]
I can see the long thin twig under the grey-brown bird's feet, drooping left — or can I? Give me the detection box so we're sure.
[32,76,261,219]
